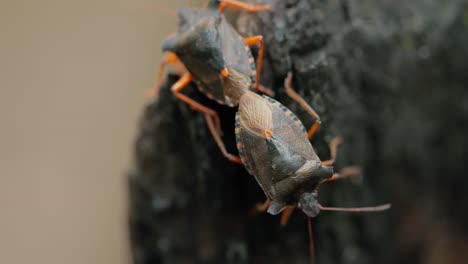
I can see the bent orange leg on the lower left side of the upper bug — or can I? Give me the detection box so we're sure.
[171,72,221,134]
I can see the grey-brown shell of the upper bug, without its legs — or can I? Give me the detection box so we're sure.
[162,5,256,106]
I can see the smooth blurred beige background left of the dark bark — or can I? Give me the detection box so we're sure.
[0,0,201,264]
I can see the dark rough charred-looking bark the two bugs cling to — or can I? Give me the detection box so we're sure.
[129,0,468,264]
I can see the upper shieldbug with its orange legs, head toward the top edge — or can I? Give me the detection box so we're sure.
[151,0,272,163]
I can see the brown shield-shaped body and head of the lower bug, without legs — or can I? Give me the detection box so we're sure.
[236,92,333,217]
